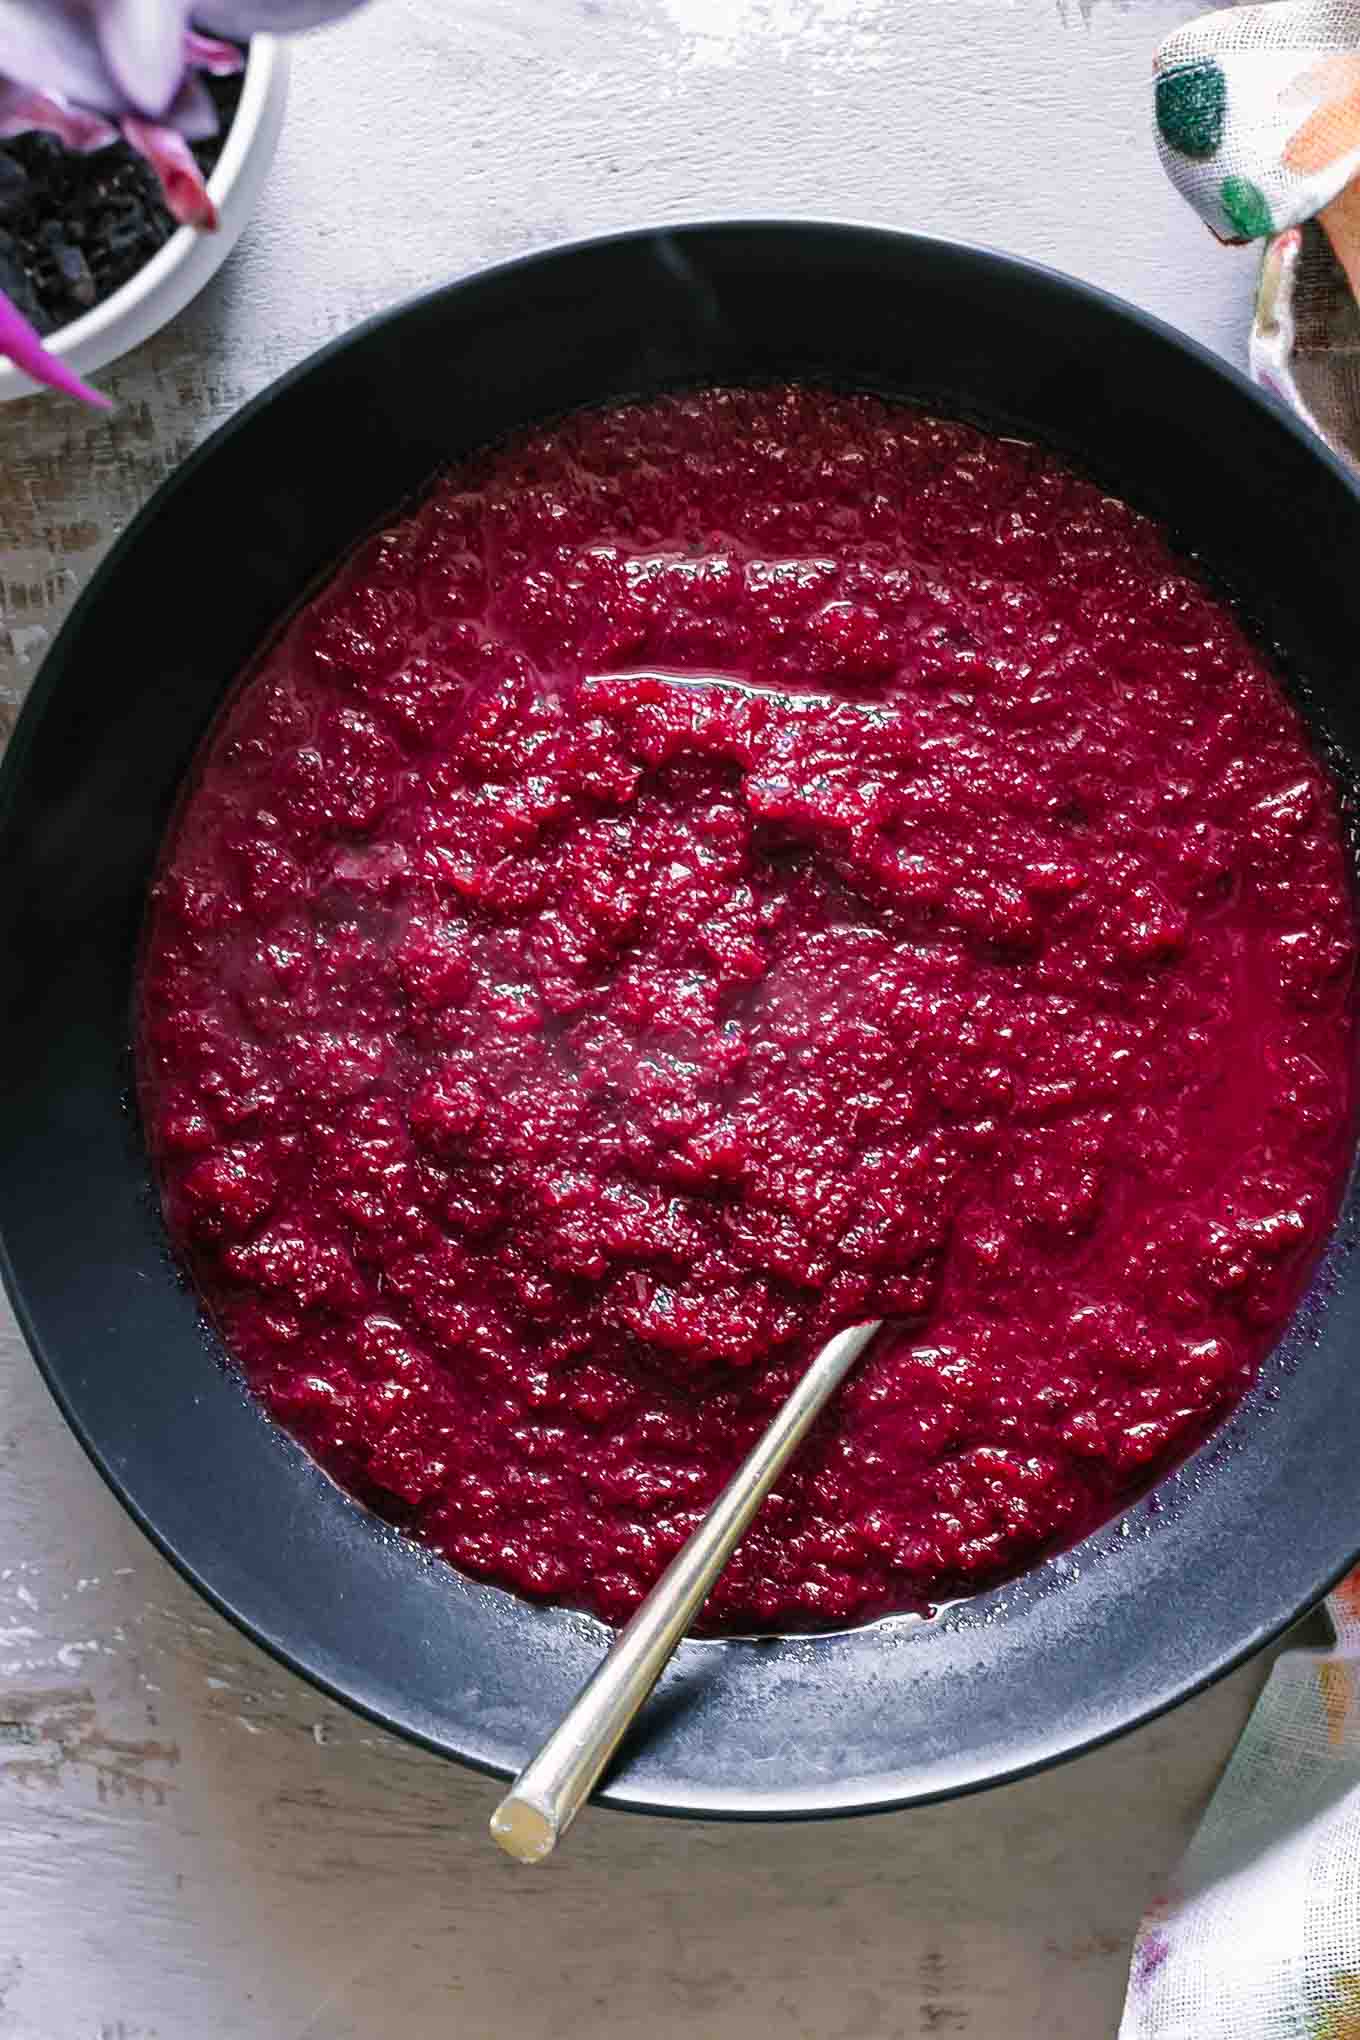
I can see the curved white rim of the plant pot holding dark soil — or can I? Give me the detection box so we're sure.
[0,35,287,402]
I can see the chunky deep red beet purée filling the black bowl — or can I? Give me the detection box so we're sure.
[141,390,1356,1630]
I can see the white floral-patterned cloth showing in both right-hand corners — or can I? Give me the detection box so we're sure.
[1119,15,1360,2040]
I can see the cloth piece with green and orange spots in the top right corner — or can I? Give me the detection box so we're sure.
[1154,0,1360,467]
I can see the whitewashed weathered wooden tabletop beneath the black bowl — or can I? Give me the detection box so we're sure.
[0,0,1288,2040]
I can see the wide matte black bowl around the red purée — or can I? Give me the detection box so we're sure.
[0,222,1360,1818]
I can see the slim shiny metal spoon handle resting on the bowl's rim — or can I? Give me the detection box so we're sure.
[491,1322,879,1863]
